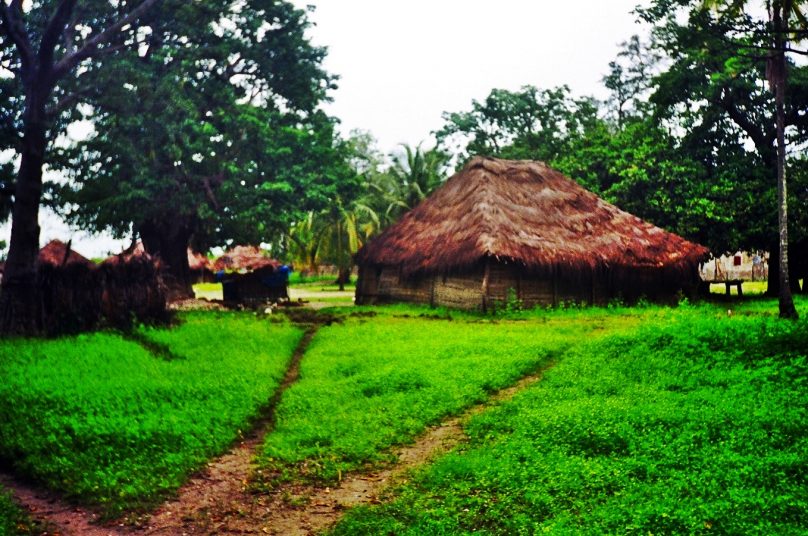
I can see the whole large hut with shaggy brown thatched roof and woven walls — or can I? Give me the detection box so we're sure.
[356,157,707,310]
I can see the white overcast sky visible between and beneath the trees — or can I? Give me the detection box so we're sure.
[0,0,645,256]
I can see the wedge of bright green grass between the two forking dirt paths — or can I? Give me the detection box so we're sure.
[259,312,640,483]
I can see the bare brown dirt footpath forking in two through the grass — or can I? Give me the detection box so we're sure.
[0,320,552,536]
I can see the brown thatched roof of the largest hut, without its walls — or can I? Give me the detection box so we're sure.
[357,157,707,274]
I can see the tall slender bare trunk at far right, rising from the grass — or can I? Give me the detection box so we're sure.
[769,3,798,319]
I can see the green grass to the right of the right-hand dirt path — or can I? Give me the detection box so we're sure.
[334,300,808,535]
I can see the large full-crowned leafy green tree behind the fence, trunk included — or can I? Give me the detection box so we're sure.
[47,0,350,295]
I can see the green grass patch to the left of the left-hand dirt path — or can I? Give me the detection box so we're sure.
[0,313,301,515]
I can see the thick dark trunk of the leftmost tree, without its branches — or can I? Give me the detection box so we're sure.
[0,88,47,335]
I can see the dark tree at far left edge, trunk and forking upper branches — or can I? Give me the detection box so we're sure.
[0,0,157,334]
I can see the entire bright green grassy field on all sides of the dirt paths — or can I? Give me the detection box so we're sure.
[0,298,808,534]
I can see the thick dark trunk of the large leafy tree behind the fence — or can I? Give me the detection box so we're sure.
[138,216,194,300]
